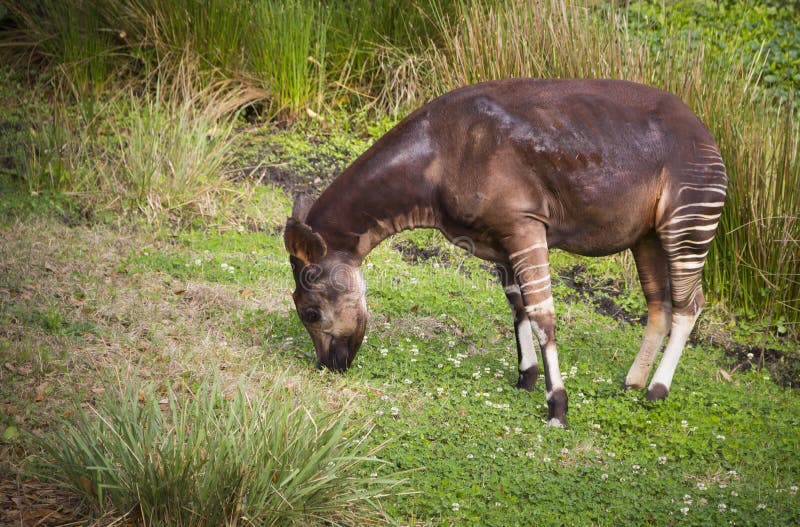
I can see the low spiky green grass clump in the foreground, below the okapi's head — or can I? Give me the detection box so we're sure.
[33,379,394,527]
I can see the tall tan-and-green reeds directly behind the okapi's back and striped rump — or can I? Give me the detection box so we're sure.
[429,0,800,332]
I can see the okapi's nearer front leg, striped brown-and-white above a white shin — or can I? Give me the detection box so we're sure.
[507,223,567,428]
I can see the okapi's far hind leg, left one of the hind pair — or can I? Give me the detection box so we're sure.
[622,235,672,390]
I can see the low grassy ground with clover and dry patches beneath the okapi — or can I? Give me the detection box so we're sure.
[0,121,800,525]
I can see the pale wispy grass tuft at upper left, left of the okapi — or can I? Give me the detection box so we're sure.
[107,62,241,219]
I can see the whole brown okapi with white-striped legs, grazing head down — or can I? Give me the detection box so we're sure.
[284,79,726,427]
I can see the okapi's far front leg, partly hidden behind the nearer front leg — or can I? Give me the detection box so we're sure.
[495,264,539,391]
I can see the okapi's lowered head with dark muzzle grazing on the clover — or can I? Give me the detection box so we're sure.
[283,196,367,371]
